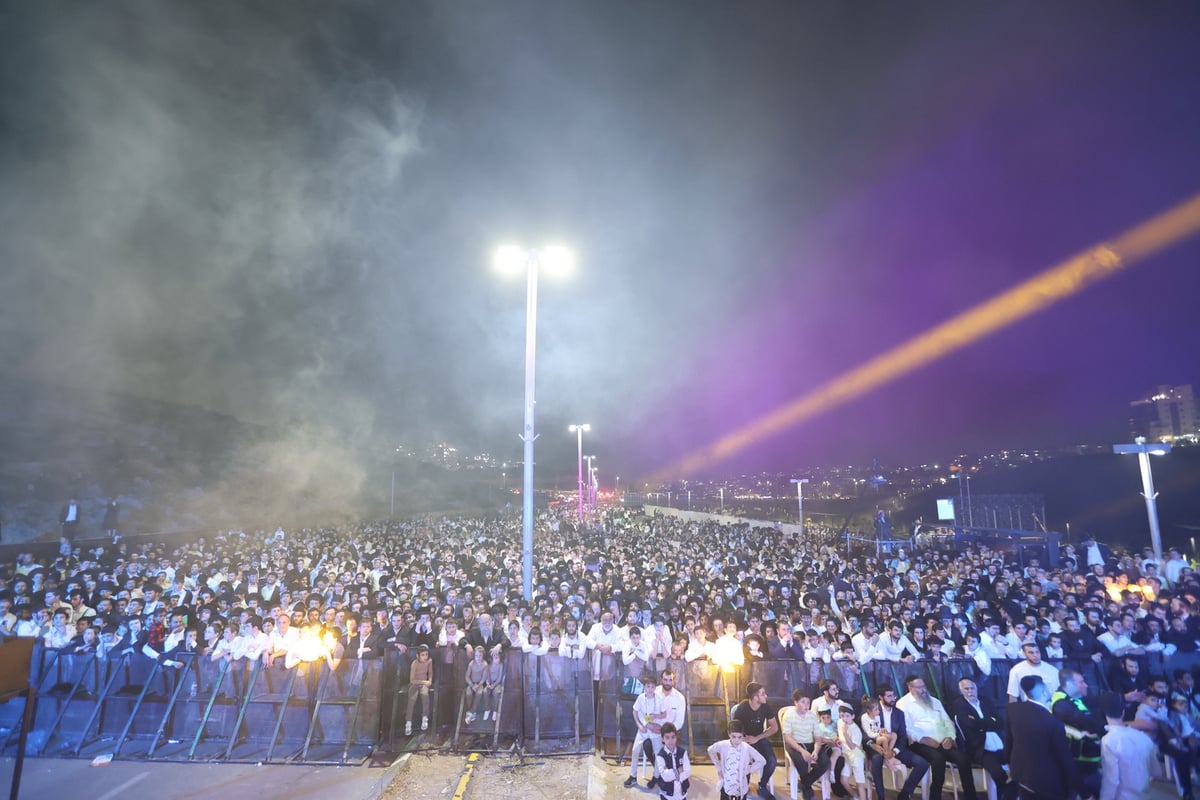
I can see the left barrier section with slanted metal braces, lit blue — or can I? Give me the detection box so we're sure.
[0,649,383,764]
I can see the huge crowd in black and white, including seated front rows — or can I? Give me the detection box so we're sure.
[0,509,1200,800]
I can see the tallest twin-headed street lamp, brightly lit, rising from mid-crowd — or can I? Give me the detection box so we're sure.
[496,245,572,600]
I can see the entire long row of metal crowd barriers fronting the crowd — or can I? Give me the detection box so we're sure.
[7,650,1200,764]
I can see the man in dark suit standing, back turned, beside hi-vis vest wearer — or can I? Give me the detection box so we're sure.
[1004,675,1078,800]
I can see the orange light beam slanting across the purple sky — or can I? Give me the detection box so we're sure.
[644,194,1200,482]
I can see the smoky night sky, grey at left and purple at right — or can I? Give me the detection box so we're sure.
[0,1,1200,485]
